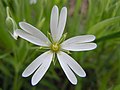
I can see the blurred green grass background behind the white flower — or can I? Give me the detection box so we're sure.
[0,0,120,90]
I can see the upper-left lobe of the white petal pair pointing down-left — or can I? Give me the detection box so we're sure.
[22,51,53,77]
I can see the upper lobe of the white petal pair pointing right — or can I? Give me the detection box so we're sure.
[62,35,95,45]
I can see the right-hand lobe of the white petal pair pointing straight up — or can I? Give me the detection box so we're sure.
[56,7,67,41]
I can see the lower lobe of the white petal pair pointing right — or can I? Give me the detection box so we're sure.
[61,43,97,51]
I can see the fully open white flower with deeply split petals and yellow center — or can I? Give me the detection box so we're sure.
[17,6,97,85]
